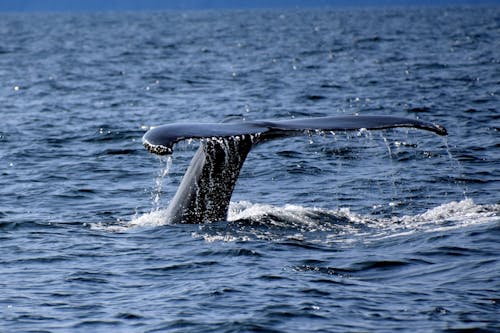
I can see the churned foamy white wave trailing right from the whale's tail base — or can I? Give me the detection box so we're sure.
[193,199,500,245]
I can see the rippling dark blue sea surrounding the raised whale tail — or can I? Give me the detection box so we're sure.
[0,6,500,332]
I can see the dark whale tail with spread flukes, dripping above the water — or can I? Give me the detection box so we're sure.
[142,116,447,223]
